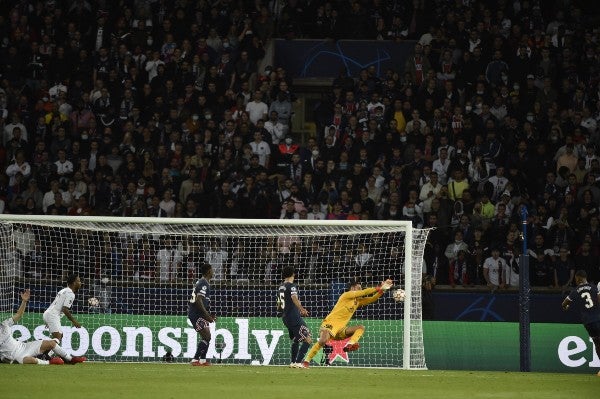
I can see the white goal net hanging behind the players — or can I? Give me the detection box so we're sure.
[0,215,428,369]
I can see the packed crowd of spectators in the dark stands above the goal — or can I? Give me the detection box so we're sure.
[0,0,600,289]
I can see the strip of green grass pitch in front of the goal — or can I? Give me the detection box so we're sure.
[0,362,600,399]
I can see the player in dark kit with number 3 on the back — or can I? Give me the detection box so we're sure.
[562,270,600,377]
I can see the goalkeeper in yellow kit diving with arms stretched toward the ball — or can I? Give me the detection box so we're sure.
[303,279,394,367]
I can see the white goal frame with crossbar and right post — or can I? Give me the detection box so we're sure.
[0,214,427,370]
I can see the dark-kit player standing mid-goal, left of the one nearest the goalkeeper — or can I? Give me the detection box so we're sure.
[188,263,216,366]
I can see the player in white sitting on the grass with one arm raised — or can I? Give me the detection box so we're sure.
[0,290,85,365]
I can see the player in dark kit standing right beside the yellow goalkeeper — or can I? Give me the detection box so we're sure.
[277,266,312,368]
